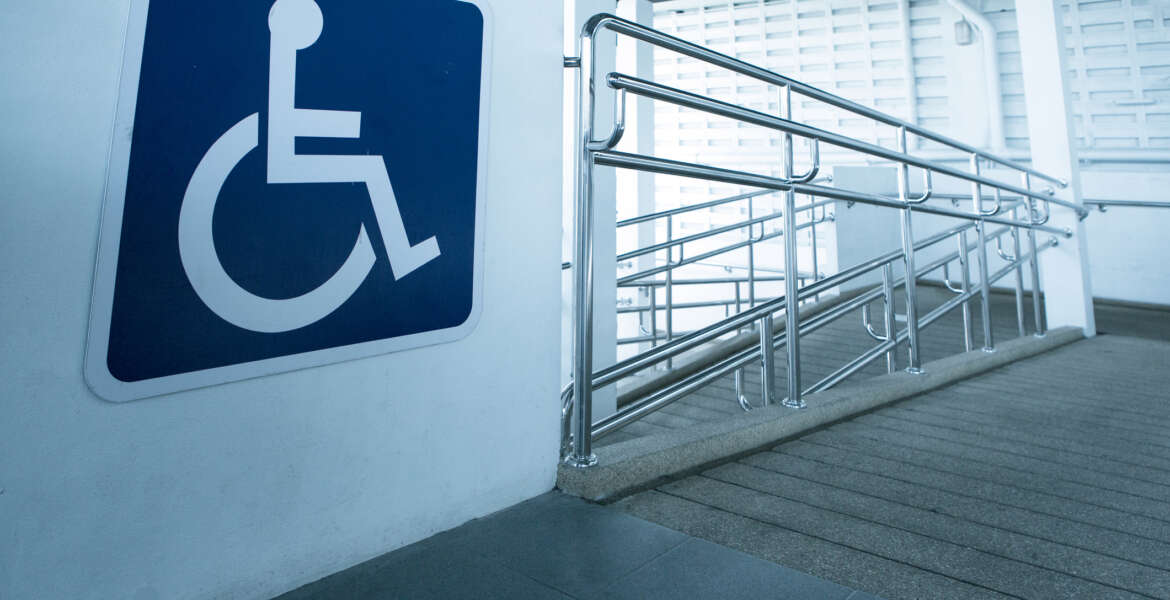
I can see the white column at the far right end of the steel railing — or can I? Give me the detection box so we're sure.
[1016,0,1096,336]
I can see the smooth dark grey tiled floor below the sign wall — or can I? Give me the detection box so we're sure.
[278,492,875,600]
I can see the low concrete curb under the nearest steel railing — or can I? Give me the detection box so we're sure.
[557,327,1085,502]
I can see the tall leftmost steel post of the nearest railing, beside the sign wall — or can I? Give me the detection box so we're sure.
[565,32,597,468]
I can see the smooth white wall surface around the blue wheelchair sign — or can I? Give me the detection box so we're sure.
[0,0,562,600]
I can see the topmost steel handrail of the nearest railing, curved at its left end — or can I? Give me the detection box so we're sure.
[583,13,1067,187]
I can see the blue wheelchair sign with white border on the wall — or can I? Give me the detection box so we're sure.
[85,0,490,401]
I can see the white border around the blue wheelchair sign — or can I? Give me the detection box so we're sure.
[84,0,495,402]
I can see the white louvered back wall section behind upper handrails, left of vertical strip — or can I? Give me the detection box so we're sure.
[654,0,913,206]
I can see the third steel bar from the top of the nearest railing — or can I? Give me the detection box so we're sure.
[593,151,1072,237]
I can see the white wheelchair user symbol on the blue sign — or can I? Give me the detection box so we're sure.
[179,0,440,333]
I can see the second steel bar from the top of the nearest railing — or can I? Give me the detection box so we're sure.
[608,73,1085,213]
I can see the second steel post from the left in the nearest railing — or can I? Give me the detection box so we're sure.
[780,85,805,408]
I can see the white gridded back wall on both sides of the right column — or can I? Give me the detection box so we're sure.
[654,0,1170,160]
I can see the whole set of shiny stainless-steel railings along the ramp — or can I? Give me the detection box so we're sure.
[562,14,1088,467]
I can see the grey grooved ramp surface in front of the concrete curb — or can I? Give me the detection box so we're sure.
[619,336,1170,600]
